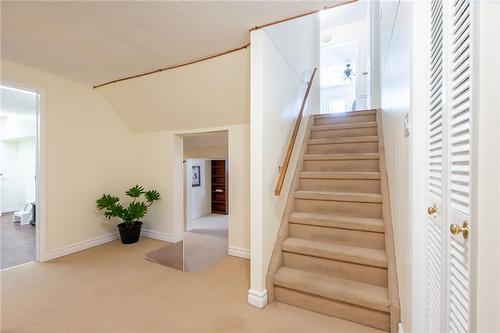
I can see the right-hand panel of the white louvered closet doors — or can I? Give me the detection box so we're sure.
[445,0,474,332]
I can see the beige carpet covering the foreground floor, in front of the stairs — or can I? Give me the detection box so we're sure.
[1,238,378,333]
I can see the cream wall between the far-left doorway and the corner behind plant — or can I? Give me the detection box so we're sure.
[1,59,133,255]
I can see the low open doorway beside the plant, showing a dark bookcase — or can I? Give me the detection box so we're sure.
[183,131,229,272]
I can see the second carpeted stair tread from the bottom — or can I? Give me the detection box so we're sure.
[283,238,387,268]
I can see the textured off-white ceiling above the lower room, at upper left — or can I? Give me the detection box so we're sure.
[1,0,345,85]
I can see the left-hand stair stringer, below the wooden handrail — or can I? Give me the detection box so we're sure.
[266,114,314,303]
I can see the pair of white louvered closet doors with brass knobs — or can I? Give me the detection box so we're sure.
[426,0,473,332]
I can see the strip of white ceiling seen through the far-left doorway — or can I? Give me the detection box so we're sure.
[0,86,37,116]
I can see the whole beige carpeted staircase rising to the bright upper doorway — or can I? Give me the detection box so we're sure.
[268,110,399,331]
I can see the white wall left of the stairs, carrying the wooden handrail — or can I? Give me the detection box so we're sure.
[249,15,319,305]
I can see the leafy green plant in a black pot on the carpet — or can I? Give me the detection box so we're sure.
[96,185,160,244]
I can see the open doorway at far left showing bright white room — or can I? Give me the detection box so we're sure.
[0,83,40,269]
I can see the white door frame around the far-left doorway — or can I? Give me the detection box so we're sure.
[0,79,47,262]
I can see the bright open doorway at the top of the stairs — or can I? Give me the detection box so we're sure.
[320,1,371,113]
